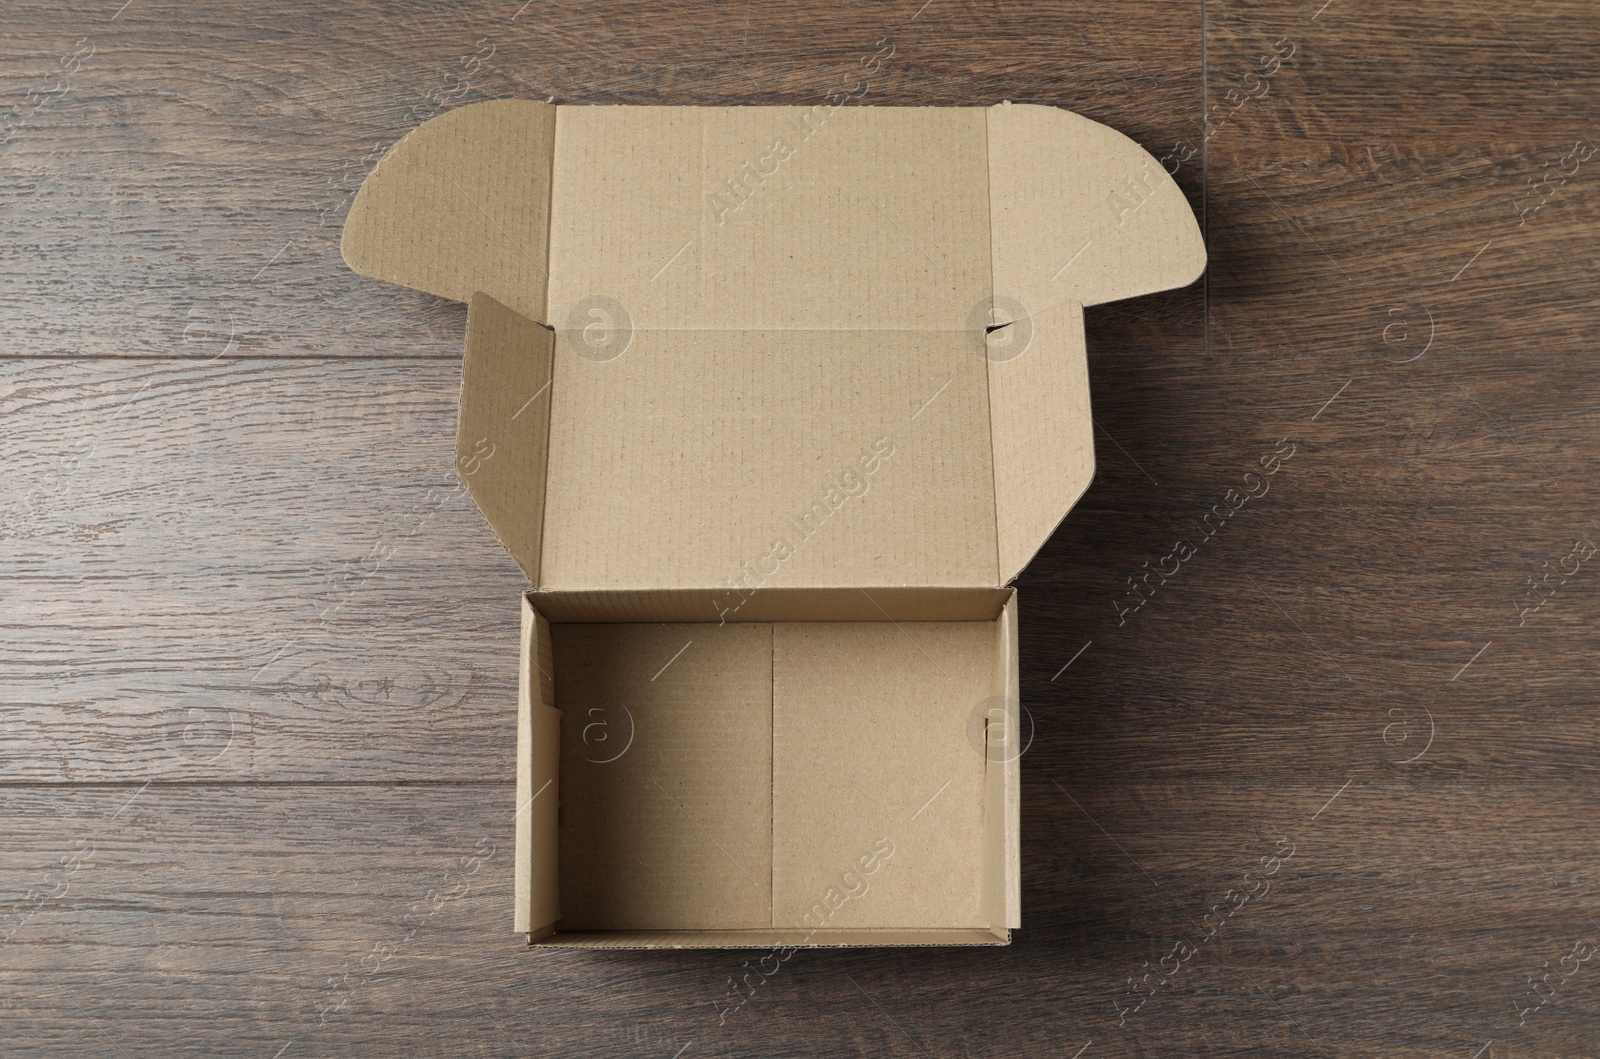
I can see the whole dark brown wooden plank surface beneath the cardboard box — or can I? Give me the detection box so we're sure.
[0,0,1600,1059]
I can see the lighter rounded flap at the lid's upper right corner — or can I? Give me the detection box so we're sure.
[987,104,1205,315]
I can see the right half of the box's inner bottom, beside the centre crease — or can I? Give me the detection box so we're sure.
[771,622,998,929]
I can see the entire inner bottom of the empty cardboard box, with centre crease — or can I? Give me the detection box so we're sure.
[550,621,1003,931]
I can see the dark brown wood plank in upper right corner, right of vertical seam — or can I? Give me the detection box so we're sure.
[1206,0,1600,356]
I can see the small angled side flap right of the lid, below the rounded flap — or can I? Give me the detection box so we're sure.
[989,302,1094,584]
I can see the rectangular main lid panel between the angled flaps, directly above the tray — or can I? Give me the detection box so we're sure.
[544,327,1000,591]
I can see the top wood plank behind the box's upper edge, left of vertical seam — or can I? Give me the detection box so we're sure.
[0,0,1200,357]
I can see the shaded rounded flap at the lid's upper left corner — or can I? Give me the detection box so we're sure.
[341,99,555,322]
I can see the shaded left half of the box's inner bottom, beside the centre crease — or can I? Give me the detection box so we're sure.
[552,622,773,929]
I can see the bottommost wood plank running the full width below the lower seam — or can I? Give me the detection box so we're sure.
[0,783,1600,1056]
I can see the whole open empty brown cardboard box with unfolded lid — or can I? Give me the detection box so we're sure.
[344,99,1205,947]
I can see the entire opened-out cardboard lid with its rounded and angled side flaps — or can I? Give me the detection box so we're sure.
[344,101,1205,598]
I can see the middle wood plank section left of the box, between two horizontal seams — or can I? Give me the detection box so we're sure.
[0,358,526,782]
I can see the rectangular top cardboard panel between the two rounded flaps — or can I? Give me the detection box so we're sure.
[549,106,989,332]
